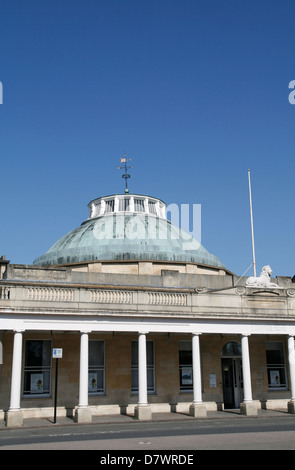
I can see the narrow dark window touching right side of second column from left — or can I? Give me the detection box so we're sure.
[88,340,105,395]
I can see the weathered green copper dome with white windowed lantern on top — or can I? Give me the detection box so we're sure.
[34,195,224,268]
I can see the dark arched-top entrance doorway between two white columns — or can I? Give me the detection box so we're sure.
[221,341,243,409]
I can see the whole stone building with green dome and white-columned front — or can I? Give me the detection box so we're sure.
[0,188,295,427]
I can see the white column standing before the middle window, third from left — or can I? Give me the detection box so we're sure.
[135,332,152,421]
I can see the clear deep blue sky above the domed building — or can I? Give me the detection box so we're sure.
[0,0,295,276]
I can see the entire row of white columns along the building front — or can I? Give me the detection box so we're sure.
[6,330,295,427]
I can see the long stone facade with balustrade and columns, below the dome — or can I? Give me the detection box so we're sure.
[0,262,295,426]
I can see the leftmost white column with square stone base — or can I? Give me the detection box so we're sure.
[6,330,23,427]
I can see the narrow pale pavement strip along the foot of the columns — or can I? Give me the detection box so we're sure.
[0,409,295,431]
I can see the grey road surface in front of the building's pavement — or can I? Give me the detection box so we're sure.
[0,415,295,452]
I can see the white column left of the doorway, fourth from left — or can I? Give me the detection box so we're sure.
[189,333,207,418]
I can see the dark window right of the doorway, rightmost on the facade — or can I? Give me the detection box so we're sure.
[266,341,287,390]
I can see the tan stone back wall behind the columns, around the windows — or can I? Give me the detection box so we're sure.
[0,332,290,416]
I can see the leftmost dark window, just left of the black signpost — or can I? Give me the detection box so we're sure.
[23,340,51,397]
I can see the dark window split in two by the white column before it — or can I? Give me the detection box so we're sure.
[131,341,155,393]
